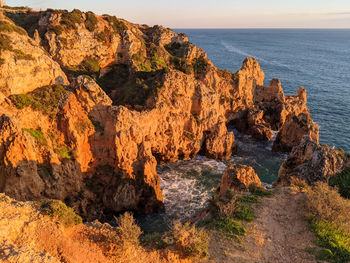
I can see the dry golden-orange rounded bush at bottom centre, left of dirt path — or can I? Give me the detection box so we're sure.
[172,222,209,258]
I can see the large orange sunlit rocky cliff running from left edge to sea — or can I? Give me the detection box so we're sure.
[0,10,318,219]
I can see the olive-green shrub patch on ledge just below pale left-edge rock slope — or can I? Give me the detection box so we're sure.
[10,85,67,117]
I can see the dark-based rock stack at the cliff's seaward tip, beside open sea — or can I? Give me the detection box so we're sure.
[272,113,319,152]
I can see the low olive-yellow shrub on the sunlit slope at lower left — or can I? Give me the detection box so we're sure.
[40,200,82,227]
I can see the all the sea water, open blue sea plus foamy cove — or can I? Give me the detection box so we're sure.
[140,29,350,231]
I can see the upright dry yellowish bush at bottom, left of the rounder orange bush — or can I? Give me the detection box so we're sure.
[115,212,142,247]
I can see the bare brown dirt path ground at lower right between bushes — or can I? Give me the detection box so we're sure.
[205,188,318,263]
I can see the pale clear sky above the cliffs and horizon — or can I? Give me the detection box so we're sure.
[5,0,350,28]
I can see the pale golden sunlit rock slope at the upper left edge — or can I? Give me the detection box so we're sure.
[0,13,69,95]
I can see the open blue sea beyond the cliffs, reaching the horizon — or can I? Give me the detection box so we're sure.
[175,28,350,151]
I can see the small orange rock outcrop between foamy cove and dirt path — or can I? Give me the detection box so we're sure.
[216,164,261,195]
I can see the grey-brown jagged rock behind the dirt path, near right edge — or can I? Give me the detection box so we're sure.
[277,136,345,185]
